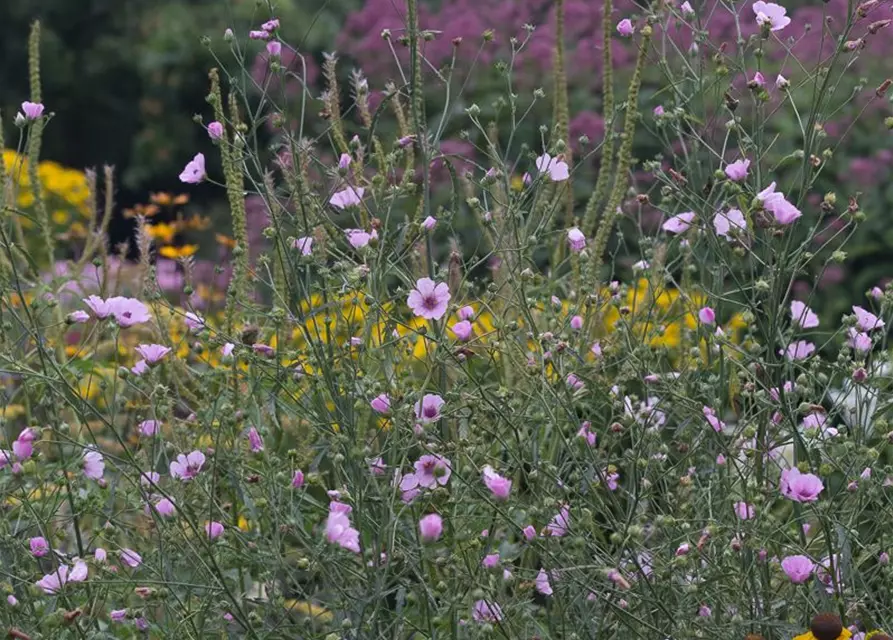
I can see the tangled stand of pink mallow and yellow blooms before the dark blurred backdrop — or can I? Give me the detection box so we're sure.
[0,0,893,640]
